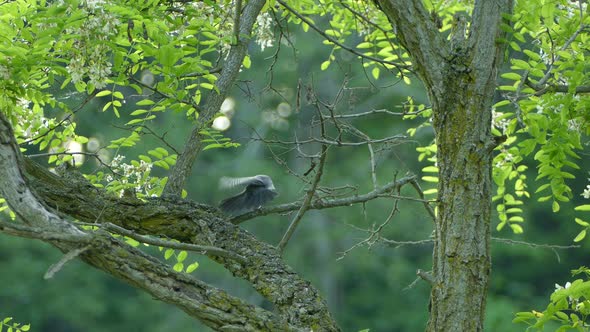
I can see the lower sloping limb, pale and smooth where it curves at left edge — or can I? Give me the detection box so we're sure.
[0,112,293,331]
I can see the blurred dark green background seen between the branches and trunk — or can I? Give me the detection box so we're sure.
[0,20,589,332]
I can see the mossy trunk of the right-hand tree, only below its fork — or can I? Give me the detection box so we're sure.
[428,74,494,331]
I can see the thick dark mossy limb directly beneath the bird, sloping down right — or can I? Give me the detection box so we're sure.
[19,147,339,331]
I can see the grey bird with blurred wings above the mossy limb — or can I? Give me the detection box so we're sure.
[219,175,279,216]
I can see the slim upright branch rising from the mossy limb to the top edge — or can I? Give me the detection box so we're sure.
[164,0,266,196]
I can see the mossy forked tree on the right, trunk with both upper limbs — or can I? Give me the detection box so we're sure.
[377,0,512,331]
